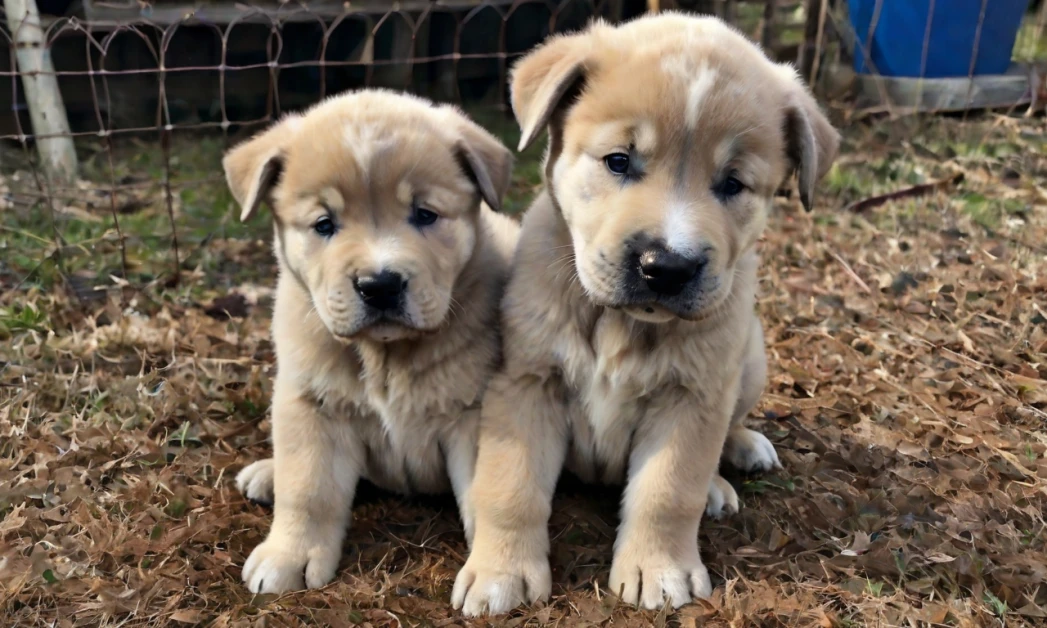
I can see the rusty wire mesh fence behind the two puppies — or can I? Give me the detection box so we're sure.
[0,0,1047,290]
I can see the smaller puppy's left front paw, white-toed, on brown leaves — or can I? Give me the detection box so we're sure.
[243,536,341,593]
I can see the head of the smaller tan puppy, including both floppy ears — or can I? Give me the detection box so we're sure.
[223,91,511,341]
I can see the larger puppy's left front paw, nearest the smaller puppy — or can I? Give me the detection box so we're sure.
[451,550,553,618]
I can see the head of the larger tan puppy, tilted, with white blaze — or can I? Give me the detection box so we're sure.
[512,14,839,321]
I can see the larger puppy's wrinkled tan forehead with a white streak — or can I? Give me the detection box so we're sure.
[577,47,784,171]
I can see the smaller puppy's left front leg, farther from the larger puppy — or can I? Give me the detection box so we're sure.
[243,379,362,593]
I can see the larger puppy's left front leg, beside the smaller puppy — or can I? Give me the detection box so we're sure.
[451,375,567,616]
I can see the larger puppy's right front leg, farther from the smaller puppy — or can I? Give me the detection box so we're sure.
[610,389,731,609]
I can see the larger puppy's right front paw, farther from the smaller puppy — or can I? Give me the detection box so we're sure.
[610,546,713,610]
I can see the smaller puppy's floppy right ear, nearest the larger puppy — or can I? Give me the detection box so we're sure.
[442,106,513,211]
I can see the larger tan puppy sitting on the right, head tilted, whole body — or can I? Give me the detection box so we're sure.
[452,14,839,615]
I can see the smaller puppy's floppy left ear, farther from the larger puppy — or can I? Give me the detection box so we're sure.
[222,116,297,222]
